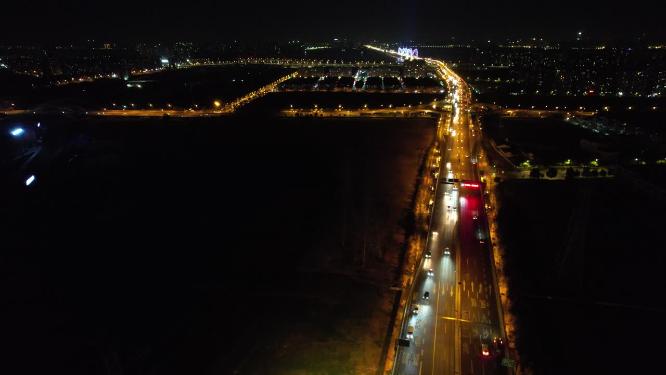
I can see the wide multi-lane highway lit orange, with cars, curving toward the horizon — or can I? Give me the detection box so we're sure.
[368,46,506,375]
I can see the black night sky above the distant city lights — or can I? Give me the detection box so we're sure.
[0,0,666,43]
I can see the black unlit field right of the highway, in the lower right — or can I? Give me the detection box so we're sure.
[498,179,666,374]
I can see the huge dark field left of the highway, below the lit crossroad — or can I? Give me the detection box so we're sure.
[0,117,434,374]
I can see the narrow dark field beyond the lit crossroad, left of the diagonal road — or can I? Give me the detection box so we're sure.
[0,65,292,109]
